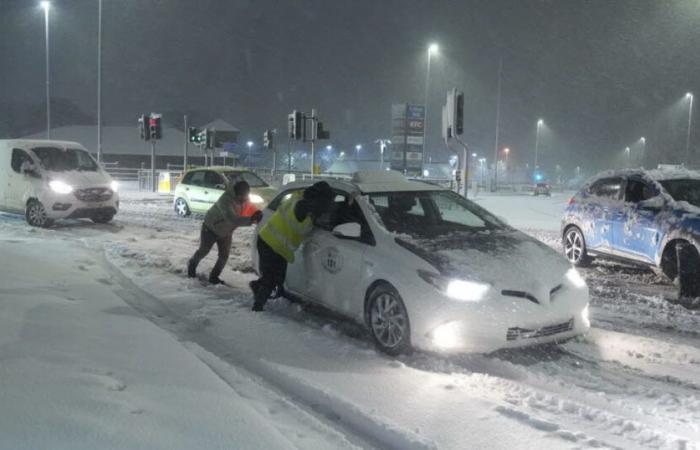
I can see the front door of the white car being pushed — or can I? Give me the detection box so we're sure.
[303,192,373,315]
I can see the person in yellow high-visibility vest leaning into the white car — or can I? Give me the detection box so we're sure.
[250,181,334,311]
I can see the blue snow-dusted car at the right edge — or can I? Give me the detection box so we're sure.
[562,169,700,297]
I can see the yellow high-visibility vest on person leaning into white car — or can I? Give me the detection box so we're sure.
[258,192,313,263]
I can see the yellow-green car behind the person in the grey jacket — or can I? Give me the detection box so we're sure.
[173,167,277,217]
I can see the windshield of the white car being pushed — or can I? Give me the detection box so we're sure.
[369,191,505,238]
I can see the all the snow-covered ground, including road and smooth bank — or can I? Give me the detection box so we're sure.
[0,194,700,449]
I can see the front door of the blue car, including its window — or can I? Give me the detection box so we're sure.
[613,177,662,264]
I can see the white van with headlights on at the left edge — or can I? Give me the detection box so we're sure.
[0,139,119,227]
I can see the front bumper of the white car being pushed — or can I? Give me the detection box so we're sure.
[412,286,590,353]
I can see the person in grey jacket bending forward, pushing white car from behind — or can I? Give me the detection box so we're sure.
[187,181,262,284]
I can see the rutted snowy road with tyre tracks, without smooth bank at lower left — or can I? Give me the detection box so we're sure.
[0,195,700,449]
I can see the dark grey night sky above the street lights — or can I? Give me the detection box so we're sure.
[0,0,700,172]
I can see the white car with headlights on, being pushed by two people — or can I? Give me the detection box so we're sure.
[254,171,590,355]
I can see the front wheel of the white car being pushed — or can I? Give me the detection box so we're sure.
[368,284,411,356]
